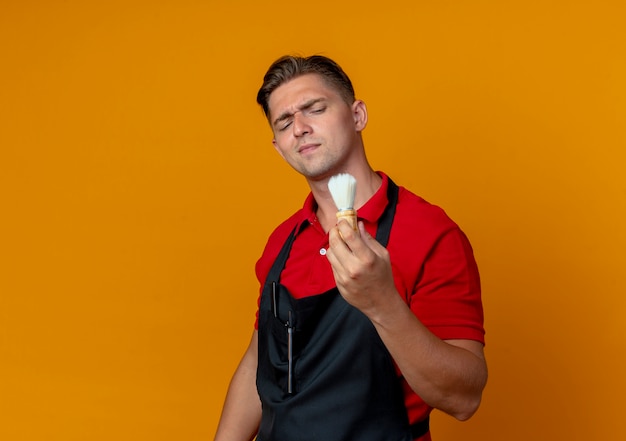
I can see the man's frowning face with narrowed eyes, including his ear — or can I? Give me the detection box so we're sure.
[268,74,367,180]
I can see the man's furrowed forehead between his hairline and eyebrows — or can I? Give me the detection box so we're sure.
[268,74,341,115]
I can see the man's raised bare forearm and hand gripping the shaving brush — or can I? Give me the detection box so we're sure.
[326,222,487,420]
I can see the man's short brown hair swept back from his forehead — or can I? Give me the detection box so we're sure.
[256,55,355,118]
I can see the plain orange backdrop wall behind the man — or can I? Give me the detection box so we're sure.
[0,0,626,441]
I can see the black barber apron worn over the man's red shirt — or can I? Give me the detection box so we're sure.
[257,179,428,441]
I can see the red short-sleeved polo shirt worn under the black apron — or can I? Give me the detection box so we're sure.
[255,173,485,434]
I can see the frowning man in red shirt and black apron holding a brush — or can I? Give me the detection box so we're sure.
[215,56,487,441]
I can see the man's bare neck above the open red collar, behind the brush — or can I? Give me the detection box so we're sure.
[309,166,382,231]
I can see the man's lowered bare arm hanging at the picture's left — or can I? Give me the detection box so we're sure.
[215,330,261,441]
